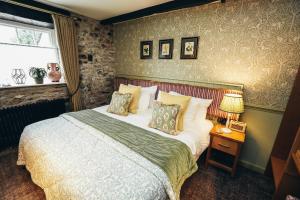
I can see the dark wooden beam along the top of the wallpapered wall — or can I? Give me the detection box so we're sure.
[101,0,225,25]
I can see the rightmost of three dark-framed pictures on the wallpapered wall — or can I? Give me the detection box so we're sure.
[180,37,199,59]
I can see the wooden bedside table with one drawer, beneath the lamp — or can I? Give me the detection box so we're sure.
[205,124,245,176]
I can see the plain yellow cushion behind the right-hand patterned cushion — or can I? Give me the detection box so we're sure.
[157,92,192,131]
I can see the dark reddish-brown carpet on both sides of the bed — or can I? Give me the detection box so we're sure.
[0,149,274,200]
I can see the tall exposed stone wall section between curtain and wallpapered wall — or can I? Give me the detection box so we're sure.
[76,15,115,108]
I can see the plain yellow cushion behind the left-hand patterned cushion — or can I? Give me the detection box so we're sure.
[119,84,141,113]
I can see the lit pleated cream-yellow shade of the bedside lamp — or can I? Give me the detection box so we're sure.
[220,94,244,114]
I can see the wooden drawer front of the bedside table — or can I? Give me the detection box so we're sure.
[212,136,238,155]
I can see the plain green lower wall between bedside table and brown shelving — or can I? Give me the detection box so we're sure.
[240,107,283,173]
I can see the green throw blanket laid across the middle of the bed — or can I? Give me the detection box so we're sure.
[67,110,198,199]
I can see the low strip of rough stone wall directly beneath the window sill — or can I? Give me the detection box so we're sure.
[0,84,68,108]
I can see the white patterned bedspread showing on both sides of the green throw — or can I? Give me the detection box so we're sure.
[17,106,212,200]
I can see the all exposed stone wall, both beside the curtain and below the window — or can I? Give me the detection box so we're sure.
[0,15,114,108]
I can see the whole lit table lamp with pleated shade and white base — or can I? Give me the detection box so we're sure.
[219,94,244,133]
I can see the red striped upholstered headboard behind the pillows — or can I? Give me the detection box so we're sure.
[115,77,243,120]
